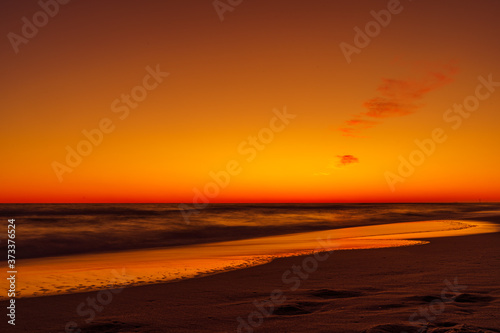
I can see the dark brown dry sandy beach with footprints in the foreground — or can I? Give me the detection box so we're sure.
[0,216,500,332]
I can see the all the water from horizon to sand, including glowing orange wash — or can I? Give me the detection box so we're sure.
[0,203,500,299]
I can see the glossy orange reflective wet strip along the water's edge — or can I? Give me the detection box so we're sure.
[0,220,500,300]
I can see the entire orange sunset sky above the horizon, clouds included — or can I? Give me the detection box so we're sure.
[0,0,500,205]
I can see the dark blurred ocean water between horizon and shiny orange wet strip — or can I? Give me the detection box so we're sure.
[0,203,500,259]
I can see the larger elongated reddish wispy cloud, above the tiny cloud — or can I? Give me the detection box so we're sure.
[339,64,458,137]
